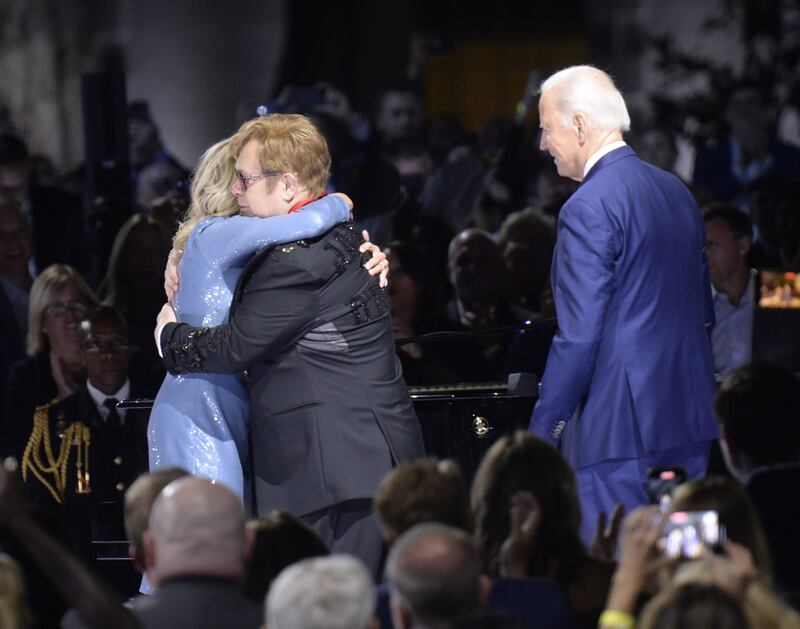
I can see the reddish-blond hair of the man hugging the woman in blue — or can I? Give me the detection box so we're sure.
[230,114,331,196]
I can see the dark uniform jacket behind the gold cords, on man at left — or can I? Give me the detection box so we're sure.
[25,384,149,563]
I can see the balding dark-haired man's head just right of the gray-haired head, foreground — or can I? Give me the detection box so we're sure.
[386,523,490,629]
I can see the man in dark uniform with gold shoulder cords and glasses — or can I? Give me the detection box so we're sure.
[22,302,152,594]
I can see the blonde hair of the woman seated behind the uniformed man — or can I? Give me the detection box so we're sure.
[25,264,97,356]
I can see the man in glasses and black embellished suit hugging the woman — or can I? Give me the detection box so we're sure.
[156,114,424,576]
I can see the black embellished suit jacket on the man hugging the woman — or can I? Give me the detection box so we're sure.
[161,224,424,515]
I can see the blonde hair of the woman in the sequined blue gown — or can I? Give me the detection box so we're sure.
[172,138,239,253]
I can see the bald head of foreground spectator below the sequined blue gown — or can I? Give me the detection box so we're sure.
[145,477,245,583]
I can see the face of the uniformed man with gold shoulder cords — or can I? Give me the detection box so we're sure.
[83,321,128,395]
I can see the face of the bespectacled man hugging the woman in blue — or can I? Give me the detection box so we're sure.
[231,140,291,218]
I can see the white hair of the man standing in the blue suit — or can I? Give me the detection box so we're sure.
[539,66,631,131]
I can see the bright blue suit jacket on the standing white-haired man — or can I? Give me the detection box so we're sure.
[531,146,717,468]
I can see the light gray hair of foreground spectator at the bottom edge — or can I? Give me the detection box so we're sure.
[264,555,376,629]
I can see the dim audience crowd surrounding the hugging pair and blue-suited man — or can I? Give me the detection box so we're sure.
[0,72,800,629]
